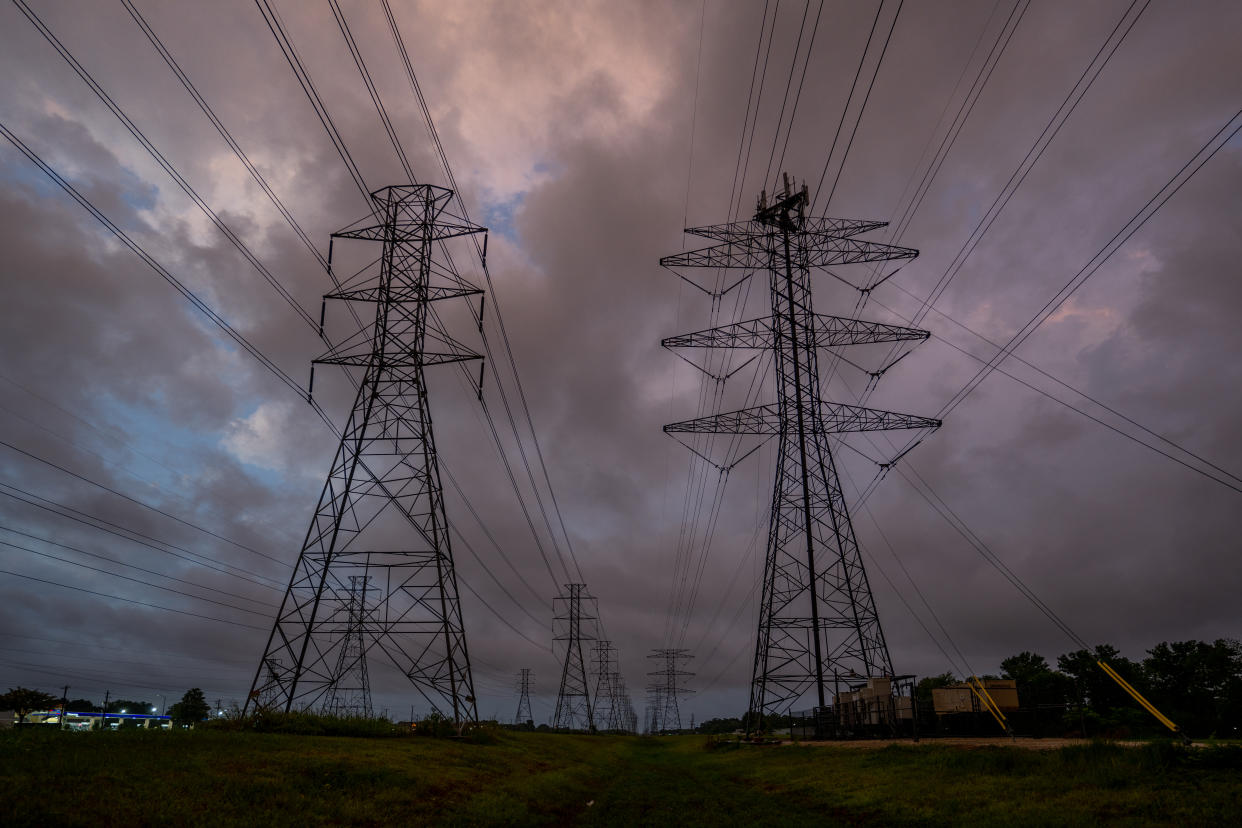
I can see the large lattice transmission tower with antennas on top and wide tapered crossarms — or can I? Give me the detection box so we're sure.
[660,175,940,729]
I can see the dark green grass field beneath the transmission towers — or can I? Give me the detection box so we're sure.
[0,730,1242,827]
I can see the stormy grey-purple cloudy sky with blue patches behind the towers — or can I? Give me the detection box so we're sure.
[0,0,1242,720]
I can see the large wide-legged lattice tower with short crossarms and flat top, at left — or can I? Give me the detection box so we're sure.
[246,185,487,725]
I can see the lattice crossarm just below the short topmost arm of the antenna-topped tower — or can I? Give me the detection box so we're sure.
[660,234,919,269]
